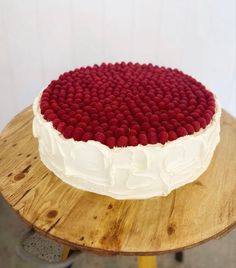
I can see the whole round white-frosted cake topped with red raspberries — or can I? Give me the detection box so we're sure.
[33,62,221,199]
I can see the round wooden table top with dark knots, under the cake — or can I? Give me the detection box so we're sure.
[0,108,236,255]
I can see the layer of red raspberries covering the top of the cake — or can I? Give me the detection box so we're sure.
[40,62,215,148]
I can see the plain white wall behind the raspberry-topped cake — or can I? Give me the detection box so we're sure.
[0,0,236,129]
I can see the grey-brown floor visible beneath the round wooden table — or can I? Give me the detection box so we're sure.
[0,197,236,268]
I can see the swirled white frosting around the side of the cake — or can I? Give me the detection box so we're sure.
[33,92,221,199]
